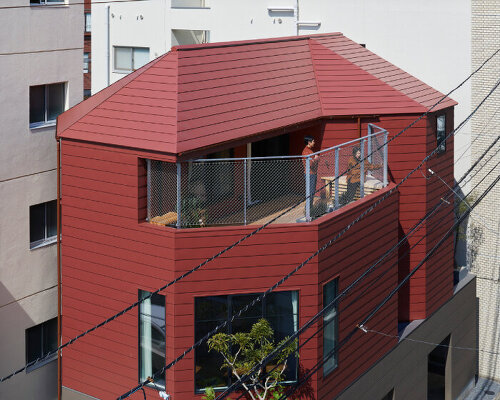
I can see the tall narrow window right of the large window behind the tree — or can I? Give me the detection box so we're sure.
[323,278,338,376]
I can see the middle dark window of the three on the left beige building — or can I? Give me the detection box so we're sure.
[30,200,57,249]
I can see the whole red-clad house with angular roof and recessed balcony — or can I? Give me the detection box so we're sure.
[57,33,476,400]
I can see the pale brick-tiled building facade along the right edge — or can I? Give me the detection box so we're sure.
[468,0,500,380]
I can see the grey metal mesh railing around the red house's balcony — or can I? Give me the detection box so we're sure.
[147,124,388,228]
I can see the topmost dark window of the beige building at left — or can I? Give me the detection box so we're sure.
[30,83,66,128]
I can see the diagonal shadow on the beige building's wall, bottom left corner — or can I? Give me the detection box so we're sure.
[0,283,57,400]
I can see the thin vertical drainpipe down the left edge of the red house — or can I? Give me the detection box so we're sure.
[57,139,62,400]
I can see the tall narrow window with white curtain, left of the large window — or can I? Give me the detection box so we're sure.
[139,290,166,388]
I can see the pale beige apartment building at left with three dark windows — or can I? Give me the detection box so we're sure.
[0,0,83,400]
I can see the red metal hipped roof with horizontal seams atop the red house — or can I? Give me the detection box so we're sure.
[57,33,456,154]
